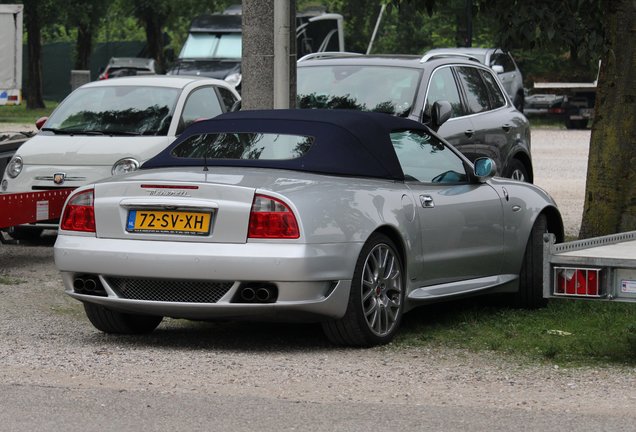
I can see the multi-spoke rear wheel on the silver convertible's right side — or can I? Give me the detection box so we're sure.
[322,233,404,347]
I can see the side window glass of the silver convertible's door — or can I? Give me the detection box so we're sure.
[391,130,468,183]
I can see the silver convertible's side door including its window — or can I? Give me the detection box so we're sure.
[391,131,504,286]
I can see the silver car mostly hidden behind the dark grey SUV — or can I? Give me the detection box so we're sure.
[424,48,525,112]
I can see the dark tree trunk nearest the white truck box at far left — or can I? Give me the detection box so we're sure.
[24,4,44,109]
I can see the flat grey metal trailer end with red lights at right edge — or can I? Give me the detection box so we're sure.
[543,231,636,302]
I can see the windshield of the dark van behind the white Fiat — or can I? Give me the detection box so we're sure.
[179,33,241,59]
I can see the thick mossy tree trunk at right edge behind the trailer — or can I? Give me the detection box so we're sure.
[580,0,636,238]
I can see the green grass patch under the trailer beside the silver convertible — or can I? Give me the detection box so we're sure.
[394,299,636,366]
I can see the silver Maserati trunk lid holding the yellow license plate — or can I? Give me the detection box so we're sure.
[95,172,255,243]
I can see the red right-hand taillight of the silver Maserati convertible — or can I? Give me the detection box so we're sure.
[247,194,300,239]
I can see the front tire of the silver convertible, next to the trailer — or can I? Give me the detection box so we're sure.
[512,214,548,309]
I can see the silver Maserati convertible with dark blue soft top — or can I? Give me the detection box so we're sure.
[55,107,563,346]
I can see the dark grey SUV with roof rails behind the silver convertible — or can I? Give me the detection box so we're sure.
[297,53,533,182]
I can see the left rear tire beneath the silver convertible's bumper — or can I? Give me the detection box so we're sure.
[84,303,163,334]
